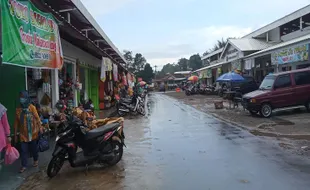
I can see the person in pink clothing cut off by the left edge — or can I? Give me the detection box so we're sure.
[0,103,11,165]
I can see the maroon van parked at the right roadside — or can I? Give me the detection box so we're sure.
[242,68,310,118]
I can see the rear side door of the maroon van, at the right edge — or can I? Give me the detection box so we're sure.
[293,71,310,105]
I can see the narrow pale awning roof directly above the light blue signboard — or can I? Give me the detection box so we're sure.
[244,34,310,58]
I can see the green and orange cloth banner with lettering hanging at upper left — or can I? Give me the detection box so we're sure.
[0,0,63,69]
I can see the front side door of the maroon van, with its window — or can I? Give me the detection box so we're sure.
[271,74,296,108]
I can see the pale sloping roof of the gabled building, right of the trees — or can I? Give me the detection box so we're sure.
[228,38,274,51]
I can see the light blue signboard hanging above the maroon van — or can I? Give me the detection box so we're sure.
[271,44,309,64]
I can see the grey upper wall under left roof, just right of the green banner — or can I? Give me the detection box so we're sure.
[61,39,101,67]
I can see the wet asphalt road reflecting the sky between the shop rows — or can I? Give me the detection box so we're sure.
[20,94,310,190]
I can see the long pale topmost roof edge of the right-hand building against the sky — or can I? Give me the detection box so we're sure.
[242,5,310,38]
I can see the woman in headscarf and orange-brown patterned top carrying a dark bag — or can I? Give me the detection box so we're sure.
[14,91,43,173]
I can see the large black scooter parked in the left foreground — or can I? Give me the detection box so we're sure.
[47,116,126,178]
